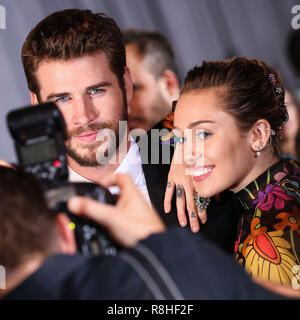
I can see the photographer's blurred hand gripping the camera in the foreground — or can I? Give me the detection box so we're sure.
[68,174,165,247]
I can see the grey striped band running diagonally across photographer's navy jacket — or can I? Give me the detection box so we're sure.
[120,243,184,300]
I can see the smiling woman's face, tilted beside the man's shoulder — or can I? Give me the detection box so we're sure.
[174,88,255,197]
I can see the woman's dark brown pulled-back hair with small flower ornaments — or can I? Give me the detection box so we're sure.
[181,57,288,153]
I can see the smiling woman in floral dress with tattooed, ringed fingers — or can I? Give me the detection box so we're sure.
[165,58,300,289]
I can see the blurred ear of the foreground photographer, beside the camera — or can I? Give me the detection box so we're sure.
[56,213,77,254]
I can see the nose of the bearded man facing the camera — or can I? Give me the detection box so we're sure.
[72,97,99,125]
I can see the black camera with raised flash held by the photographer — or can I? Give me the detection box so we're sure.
[7,103,119,256]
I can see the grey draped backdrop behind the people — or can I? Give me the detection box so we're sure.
[0,0,300,161]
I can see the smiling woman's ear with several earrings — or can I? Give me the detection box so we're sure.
[250,119,271,151]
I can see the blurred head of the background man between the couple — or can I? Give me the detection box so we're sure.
[123,29,180,136]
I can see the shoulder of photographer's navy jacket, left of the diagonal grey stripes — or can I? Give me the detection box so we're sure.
[6,254,151,300]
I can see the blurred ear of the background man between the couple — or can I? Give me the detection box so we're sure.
[158,69,179,105]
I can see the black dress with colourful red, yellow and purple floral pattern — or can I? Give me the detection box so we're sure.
[235,159,300,290]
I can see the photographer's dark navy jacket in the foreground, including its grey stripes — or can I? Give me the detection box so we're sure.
[6,227,282,300]
